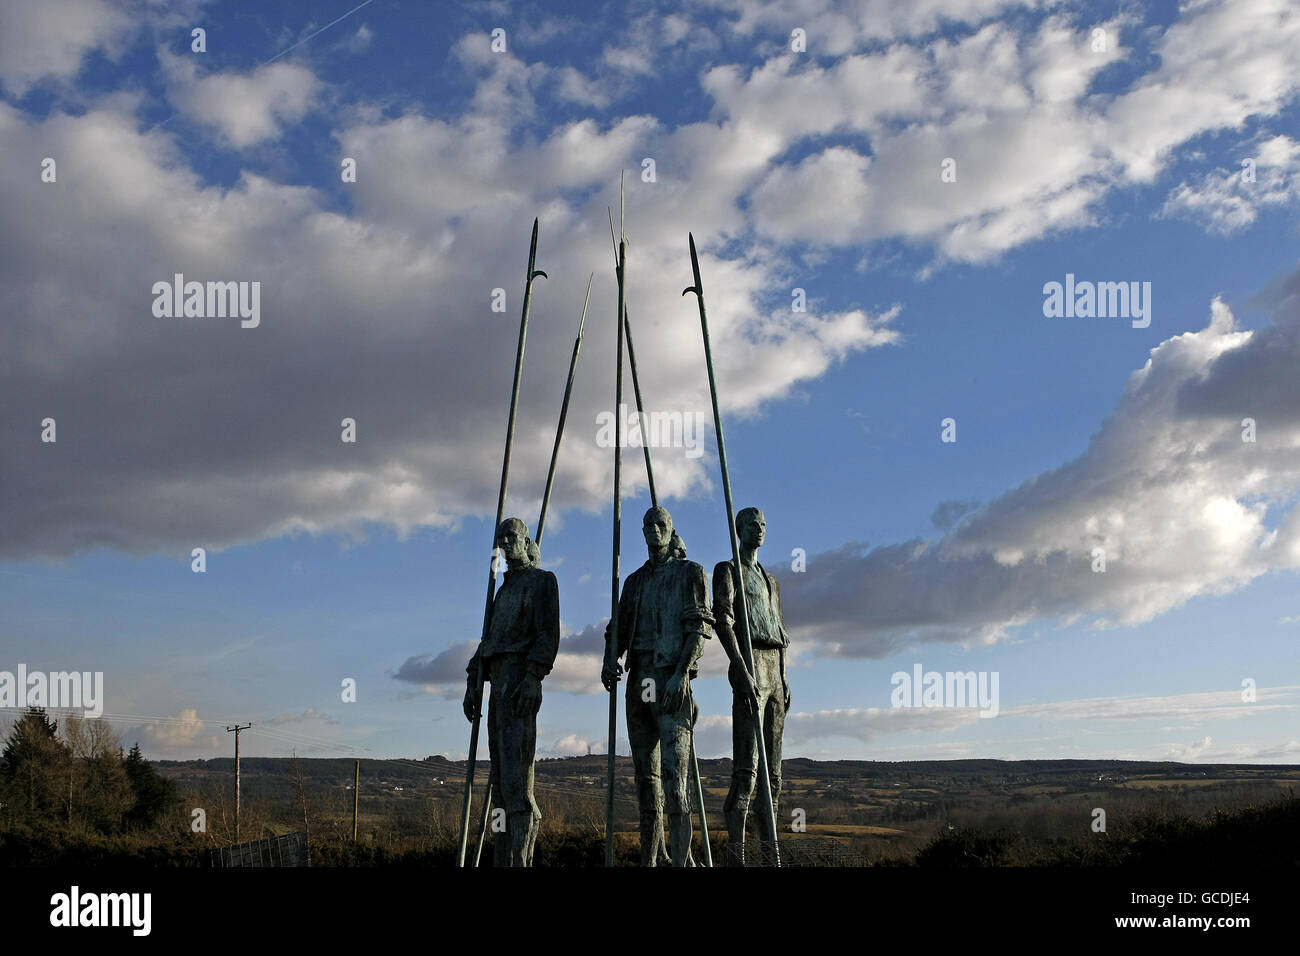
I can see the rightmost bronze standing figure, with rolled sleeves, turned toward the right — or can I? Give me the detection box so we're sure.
[714,507,790,866]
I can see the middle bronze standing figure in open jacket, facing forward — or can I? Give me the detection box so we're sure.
[601,507,714,866]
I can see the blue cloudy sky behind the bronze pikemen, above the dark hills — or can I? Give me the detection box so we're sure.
[0,0,1300,762]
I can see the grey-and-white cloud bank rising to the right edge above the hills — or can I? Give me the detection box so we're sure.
[784,283,1300,657]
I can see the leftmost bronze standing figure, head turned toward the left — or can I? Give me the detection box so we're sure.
[464,518,560,866]
